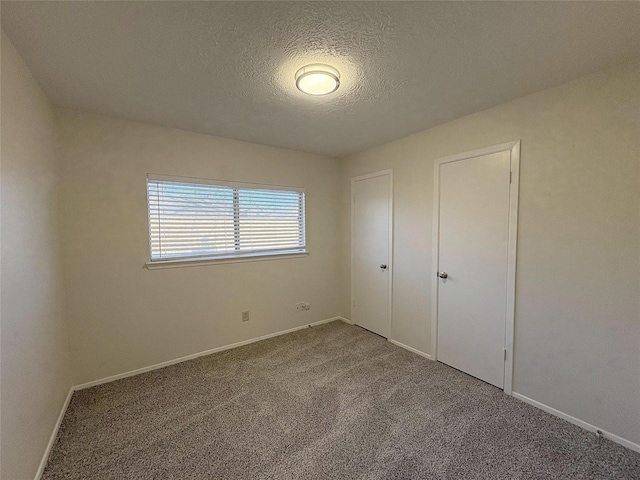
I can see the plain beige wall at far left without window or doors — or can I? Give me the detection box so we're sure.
[0,33,73,480]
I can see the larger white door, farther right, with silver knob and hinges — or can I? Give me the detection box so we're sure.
[436,151,511,388]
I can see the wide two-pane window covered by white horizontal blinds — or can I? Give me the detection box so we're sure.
[147,175,305,262]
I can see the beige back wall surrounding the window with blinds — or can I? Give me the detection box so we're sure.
[58,110,340,382]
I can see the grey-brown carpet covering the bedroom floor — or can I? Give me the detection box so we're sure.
[42,321,640,480]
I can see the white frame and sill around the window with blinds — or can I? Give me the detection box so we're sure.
[145,173,309,270]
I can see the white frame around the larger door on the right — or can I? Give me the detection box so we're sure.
[431,140,520,395]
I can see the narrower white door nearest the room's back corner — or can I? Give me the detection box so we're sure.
[351,171,392,338]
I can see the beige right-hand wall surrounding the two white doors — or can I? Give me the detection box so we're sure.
[341,63,640,443]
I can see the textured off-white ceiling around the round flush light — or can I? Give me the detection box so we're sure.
[1,1,640,156]
